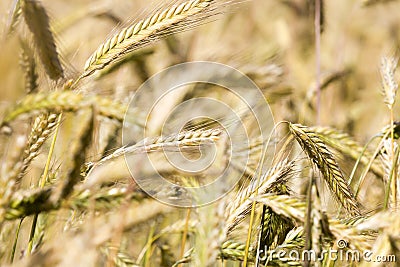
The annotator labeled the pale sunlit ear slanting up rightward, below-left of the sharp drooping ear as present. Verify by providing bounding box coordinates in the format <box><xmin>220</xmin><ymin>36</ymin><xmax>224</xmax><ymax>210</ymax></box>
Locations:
<box><xmin>226</xmin><ymin>160</ymin><xmax>294</xmax><ymax>235</ymax></box>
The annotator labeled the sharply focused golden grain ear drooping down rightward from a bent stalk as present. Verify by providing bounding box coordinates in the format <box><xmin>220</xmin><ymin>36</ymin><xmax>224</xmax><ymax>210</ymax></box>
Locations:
<box><xmin>289</xmin><ymin>123</ymin><xmax>360</xmax><ymax>218</ymax></box>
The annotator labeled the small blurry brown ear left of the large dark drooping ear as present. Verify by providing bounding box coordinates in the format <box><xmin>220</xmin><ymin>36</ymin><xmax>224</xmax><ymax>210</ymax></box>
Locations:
<box><xmin>20</xmin><ymin>40</ymin><xmax>38</xmax><ymax>94</ymax></box>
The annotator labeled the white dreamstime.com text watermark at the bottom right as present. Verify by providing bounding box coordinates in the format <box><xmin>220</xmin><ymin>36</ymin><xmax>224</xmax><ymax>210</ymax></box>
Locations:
<box><xmin>259</xmin><ymin>239</ymin><xmax>396</xmax><ymax>263</ymax></box>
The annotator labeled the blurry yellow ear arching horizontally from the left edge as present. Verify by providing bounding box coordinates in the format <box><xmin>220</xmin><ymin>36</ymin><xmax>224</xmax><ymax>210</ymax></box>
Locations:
<box><xmin>2</xmin><ymin>91</ymin><xmax>127</xmax><ymax>125</ymax></box>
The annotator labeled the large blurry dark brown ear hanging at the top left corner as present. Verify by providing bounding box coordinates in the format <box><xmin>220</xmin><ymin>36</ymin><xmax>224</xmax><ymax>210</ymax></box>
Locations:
<box><xmin>21</xmin><ymin>0</ymin><xmax>64</xmax><ymax>80</ymax></box>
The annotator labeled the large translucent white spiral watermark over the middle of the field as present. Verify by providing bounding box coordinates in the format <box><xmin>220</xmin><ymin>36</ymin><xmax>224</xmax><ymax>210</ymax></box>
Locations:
<box><xmin>123</xmin><ymin>62</ymin><xmax>274</xmax><ymax>207</ymax></box>
